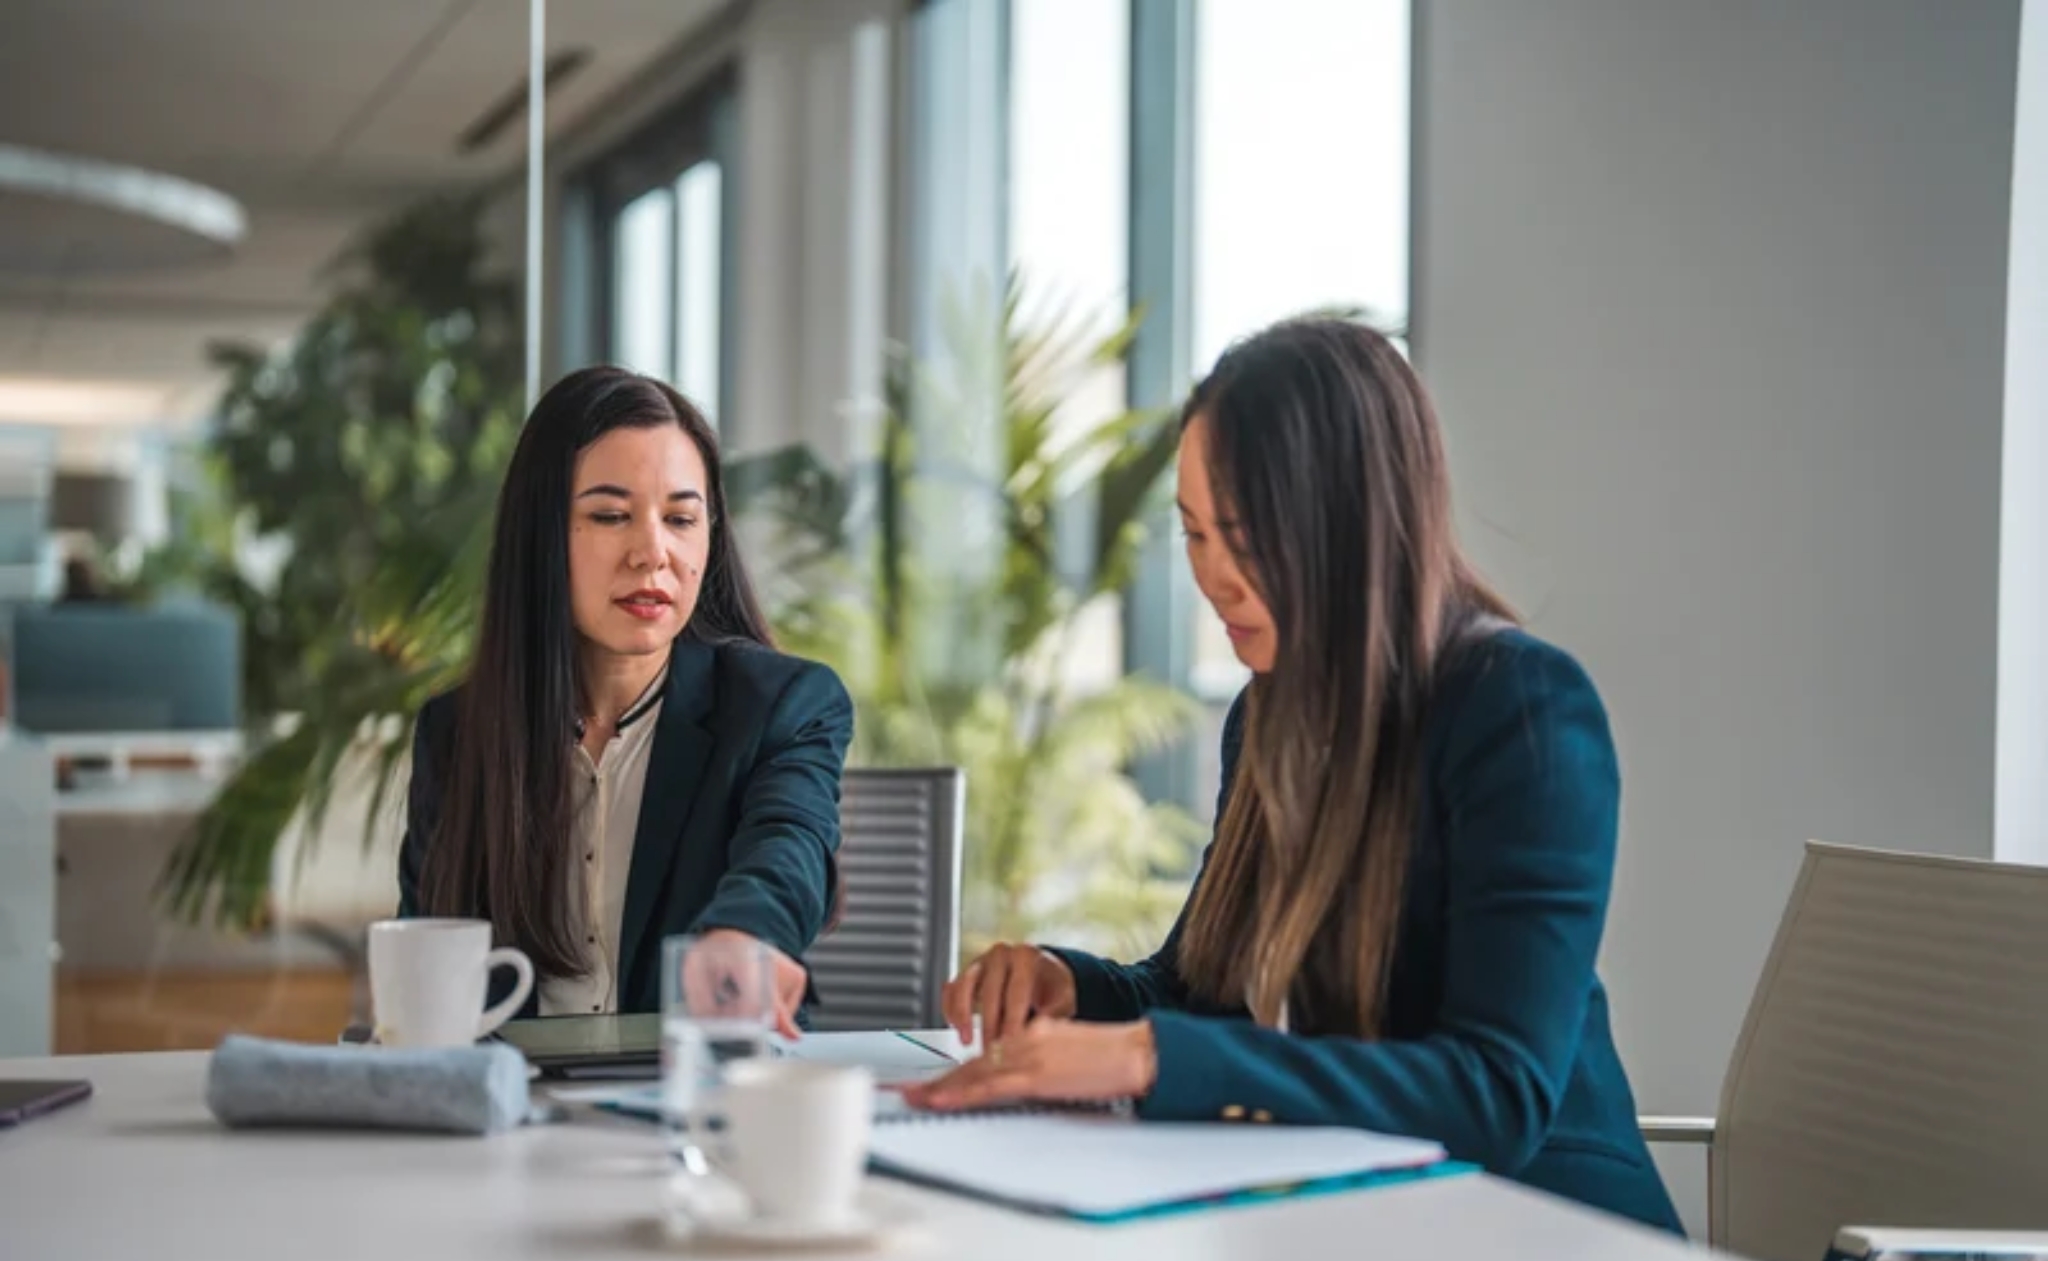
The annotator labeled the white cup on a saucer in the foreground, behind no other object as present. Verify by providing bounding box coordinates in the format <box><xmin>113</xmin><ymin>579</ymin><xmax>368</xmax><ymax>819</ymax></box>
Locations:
<box><xmin>698</xmin><ymin>1058</ymin><xmax>874</xmax><ymax>1228</ymax></box>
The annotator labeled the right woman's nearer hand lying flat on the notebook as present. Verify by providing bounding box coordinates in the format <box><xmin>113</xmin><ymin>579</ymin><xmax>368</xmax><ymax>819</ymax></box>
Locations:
<box><xmin>903</xmin><ymin>1019</ymin><xmax>1159</xmax><ymax>1112</ymax></box>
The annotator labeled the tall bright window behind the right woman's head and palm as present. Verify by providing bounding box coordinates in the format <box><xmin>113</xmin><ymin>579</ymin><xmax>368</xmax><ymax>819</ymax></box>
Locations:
<box><xmin>909</xmin><ymin>0</ymin><xmax>1411</xmax><ymax>813</ymax></box>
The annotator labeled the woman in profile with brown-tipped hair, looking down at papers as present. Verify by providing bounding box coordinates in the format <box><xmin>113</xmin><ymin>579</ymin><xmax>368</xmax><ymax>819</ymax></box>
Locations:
<box><xmin>911</xmin><ymin>319</ymin><xmax>1679</xmax><ymax>1230</ymax></box>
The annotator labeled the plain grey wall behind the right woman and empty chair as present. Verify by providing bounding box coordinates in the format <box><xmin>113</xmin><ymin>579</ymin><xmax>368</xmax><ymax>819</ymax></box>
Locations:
<box><xmin>1413</xmin><ymin>0</ymin><xmax>2019</xmax><ymax>1222</ymax></box>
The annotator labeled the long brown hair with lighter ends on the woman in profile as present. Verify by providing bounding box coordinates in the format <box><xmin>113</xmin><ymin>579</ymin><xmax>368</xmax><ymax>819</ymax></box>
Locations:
<box><xmin>1180</xmin><ymin>319</ymin><xmax>1513</xmax><ymax>1038</ymax></box>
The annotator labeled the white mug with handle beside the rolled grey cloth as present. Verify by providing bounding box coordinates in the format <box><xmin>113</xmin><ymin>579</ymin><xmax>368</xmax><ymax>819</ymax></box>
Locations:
<box><xmin>371</xmin><ymin>919</ymin><xmax>532</xmax><ymax>1046</ymax></box>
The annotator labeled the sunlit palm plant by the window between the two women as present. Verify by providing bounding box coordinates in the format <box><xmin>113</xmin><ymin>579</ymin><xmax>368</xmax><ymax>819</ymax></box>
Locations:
<box><xmin>735</xmin><ymin>278</ymin><xmax>1202</xmax><ymax>952</ymax></box>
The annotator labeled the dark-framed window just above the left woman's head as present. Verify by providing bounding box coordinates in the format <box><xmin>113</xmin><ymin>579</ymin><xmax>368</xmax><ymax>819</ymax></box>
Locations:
<box><xmin>580</xmin><ymin>80</ymin><xmax>735</xmax><ymax>420</ymax></box>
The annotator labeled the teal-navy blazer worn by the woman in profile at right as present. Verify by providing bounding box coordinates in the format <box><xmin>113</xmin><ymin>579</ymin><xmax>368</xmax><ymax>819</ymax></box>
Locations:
<box><xmin>1057</xmin><ymin>631</ymin><xmax>1681</xmax><ymax>1232</ymax></box>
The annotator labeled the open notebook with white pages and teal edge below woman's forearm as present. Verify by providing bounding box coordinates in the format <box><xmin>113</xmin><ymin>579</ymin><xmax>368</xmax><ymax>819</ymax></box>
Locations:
<box><xmin>868</xmin><ymin>1112</ymin><xmax>1475</xmax><ymax>1222</ymax></box>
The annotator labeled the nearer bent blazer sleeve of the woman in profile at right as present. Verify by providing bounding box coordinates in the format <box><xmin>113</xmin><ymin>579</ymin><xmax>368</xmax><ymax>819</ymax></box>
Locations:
<box><xmin>1139</xmin><ymin>645</ymin><xmax>1620</xmax><ymax>1173</ymax></box>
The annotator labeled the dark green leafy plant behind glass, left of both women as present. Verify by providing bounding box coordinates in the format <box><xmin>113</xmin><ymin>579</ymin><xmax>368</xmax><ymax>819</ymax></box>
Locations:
<box><xmin>149</xmin><ymin>199</ymin><xmax>522</xmax><ymax>929</ymax></box>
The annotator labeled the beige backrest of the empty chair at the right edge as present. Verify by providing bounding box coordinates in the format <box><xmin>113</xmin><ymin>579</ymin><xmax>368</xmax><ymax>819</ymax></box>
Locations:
<box><xmin>1708</xmin><ymin>843</ymin><xmax>2048</xmax><ymax>1261</ymax></box>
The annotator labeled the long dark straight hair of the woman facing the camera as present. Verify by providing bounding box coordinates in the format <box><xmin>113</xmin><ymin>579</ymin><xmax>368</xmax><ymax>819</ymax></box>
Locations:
<box><xmin>420</xmin><ymin>366</ymin><xmax>774</xmax><ymax>976</ymax></box>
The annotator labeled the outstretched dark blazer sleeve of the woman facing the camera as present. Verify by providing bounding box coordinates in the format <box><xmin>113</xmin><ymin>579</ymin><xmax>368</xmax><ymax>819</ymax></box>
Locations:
<box><xmin>690</xmin><ymin>661</ymin><xmax>854</xmax><ymax>958</ymax></box>
